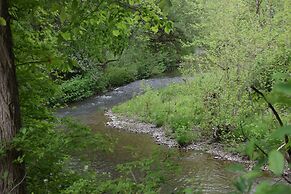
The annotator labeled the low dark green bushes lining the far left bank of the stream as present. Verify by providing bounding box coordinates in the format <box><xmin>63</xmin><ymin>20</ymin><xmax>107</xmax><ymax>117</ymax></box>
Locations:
<box><xmin>53</xmin><ymin>35</ymin><xmax>177</xmax><ymax>103</ymax></box>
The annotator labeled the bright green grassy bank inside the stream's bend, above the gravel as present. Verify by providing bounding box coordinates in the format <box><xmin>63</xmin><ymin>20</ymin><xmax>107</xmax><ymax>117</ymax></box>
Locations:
<box><xmin>113</xmin><ymin>71</ymin><xmax>291</xmax><ymax>153</ymax></box>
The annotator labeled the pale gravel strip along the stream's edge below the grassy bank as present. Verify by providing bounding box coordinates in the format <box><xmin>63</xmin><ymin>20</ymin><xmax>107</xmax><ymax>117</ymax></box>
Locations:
<box><xmin>105</xmin><ymin>110</ymin><xmax>254</xmax><ymax>166</ymax></box>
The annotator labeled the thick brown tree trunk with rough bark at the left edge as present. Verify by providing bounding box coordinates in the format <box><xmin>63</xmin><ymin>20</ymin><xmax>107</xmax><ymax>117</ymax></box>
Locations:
<box><xmin>0</xmin><ymin>0</ymin><xmax>25</xmax><ymax>194</ymax></box>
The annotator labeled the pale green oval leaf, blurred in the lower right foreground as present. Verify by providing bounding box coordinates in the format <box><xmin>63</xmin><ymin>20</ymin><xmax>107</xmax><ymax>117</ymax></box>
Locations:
<box><xmin>269</xmin><ymin>150</ymin><xmax>284</xmax><ymax>175</ymax></box>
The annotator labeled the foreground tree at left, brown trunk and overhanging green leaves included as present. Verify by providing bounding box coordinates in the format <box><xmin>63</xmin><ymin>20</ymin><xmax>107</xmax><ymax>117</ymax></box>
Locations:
<box><xmin>0</xmin><ymin>0</ymin><xmax>173</xmax><ymax>193</ymax></box>
